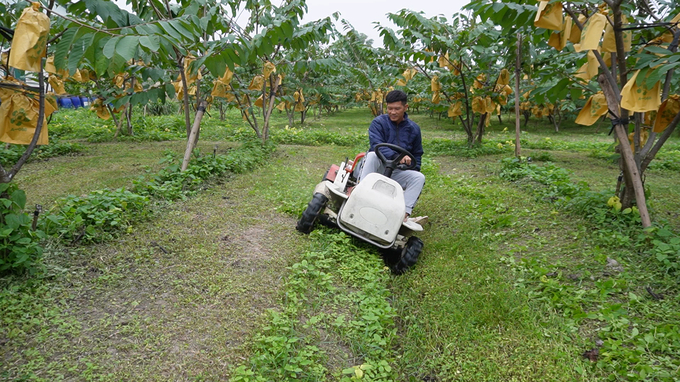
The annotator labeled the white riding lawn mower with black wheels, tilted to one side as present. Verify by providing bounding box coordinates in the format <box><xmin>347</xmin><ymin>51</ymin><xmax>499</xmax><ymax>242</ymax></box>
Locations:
<box><xmin>296</xmin><ymin>143</ymin><xmax>423</xmax><ymax>274</ymax></box>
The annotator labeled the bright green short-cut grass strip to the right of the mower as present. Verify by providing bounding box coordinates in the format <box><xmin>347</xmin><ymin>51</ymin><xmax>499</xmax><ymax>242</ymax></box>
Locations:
<box><xmin>391</xmin><ymin>160</ymin><xmax>580</xmax><ymax>381</ymax></box>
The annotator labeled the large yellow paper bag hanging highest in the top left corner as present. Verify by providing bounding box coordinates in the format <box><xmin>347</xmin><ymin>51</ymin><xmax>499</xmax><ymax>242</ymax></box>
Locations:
<box><xmin>9</xmin><ymin>2</ymin><xmax>50</xmax><ymax>72</ymax></box>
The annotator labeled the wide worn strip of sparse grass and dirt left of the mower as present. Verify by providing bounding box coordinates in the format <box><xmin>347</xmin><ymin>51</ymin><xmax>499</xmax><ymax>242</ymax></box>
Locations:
<box><xmin>0</xmin><ymin>157</ymin><xmax>299</xmax><ymax>381</ymax></box>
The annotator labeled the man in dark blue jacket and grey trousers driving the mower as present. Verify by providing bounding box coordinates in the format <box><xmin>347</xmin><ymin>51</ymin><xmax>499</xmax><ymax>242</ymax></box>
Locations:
<box><xmin>359</xmin><ymin>90</ymin><xmax>425</xmax><ymax>223</ymax></box>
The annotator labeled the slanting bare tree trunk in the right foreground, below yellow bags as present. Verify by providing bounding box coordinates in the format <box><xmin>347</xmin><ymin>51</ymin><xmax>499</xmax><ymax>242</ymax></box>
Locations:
<box><xmin>597</xmin><ymin>74</ymin><xmax>652</xmax><ymax>228</ymax></box>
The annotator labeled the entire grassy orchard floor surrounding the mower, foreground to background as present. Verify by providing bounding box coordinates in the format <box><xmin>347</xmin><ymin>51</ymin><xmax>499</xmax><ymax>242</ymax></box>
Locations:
<box><xmin>0</xmin><ymin>109</ymin><xmax>680</xmax><ymax>381</ymax></box>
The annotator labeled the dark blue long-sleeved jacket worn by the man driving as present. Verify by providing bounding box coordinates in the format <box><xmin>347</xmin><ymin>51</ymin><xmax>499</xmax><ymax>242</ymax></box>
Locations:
<box><xmin>368</xmin><ymin>113</ymin><xmax>423</xmax><ymax>171</ymax></box>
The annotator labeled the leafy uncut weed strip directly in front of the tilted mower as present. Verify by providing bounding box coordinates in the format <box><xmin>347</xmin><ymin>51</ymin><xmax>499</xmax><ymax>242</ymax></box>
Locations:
<box><xmin>231</xmin><ymin>230</ymin><xmax>396</xmax><ymax>382</ymax></box>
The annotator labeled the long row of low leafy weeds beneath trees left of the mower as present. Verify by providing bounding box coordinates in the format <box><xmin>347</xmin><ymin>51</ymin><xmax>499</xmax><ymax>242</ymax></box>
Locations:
<box><xmin>43</xmin><ymin>142</ymin><xmax>273</xmax><ymax>244</ymax></box>
